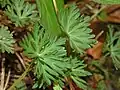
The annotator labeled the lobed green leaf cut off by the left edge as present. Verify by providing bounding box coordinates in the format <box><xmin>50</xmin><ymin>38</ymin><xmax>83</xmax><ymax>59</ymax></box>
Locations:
<box><xmin>0</xmin><ymin>26</ymin><xmax>15</xmax><ymax>53</ymax></box>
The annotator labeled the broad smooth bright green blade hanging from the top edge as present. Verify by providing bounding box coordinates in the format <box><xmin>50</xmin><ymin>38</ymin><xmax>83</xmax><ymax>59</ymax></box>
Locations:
<box><xmin>36</xmin><ymin>0</ymin><xmax>61</xmax><ymax>36</ymax></box>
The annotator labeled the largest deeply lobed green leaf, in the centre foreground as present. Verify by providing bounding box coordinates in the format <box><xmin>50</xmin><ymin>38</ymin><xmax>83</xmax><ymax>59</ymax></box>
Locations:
<box><xmin>20</xmin><ymin>24</ymin><xmax>68</xmax><ymax>88</ymax></box>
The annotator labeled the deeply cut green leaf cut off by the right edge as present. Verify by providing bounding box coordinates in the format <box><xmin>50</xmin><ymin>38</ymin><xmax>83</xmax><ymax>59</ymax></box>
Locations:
<box><xmin>103</xmin><ymin>25</ymin><xmax>120</xmax><ymax>69</ymax></box>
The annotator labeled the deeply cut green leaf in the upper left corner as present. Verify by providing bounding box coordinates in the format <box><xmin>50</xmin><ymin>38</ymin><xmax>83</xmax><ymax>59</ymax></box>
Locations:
<box><xmin>5</xmin><ymin>0</ymin><xmax>39</xmax><ymax>26</ymax></box>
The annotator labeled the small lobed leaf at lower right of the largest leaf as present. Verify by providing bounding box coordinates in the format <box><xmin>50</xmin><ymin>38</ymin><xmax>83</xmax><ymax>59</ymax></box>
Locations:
<box><xmin>66</xmin><ymin>58</ymin><xmax>91</xmax><ymax>90</ymax></box>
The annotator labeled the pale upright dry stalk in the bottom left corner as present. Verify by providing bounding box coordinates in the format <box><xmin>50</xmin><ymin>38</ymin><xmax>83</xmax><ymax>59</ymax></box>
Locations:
<box><xmin>0</xmin><ymin>58</ymin><xmax>5</xmax><ymax>90</ymax></box>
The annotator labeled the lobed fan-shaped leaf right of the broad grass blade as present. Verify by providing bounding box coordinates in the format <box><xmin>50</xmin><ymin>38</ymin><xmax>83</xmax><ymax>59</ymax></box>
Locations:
<box><xmin>59</xmin><ymin>4</ymin><xmax>95</xmax><ymax>53</ymax></box>
